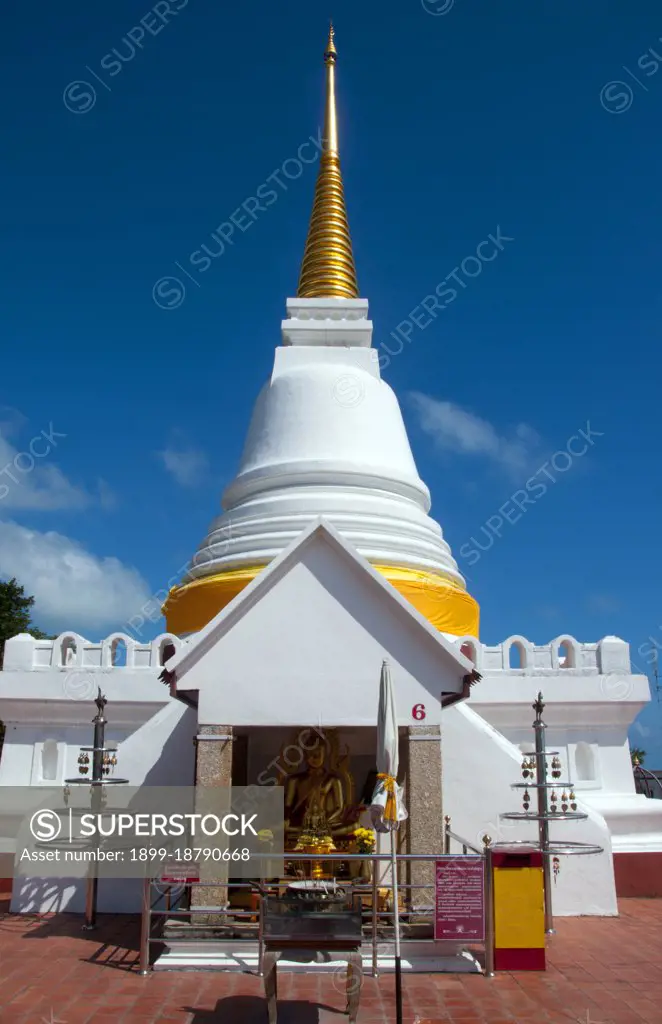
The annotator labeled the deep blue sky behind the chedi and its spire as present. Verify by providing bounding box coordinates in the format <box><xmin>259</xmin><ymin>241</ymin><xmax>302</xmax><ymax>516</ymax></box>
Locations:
<box><xmin>0</xmin><ymin>0</ymin><xmax>662</xmax><ymax>767</ymax></box>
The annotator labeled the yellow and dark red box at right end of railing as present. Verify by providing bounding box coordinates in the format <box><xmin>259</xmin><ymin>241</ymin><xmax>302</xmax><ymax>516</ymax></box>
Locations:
<box><xmin>492</xmin><ymin>846</ymin><xmax>545</xmax><ymax>971</ymax></box>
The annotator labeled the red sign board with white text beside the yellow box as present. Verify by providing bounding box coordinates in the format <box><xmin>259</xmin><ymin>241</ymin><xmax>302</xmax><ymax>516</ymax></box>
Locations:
<box><xmin>435</xmin><ymin>856</ymin><xmax>485</xmax><ymax>942</ymax></box>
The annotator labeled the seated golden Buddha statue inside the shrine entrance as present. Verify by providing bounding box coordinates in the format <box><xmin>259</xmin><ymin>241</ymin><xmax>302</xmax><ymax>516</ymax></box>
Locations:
<box><xmin>284</xmin><ymin>733</ymin><xmax>358</xmax><ymax>845</ymax></box>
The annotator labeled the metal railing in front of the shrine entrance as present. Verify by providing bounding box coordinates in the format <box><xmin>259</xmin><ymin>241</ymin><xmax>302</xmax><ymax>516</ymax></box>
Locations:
<box><xmin>139</xmin><ymin>843</ymin><xmax>494</xmax><ymax>977</ymax></box>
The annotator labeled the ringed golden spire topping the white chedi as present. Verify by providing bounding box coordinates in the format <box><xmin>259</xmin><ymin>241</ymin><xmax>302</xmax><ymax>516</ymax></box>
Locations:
<box><xmin>297</xmin><ymin>26</ymin><xmax>359</xmax><ymax>299</ymax></box>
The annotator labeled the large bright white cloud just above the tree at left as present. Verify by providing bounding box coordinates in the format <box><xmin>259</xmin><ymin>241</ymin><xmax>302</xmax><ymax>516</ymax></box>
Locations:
<box><xmin>0</xmin><ymin>522</ymin><xmax>151</xmax><ymax>635</ymax></box>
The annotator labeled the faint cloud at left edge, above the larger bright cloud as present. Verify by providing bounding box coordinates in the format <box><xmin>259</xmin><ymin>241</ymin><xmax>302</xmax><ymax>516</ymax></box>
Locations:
<box><xmin>0</xmin><ymin>419</ymin><xmax>101</xmax><ymax>513</ymax></box>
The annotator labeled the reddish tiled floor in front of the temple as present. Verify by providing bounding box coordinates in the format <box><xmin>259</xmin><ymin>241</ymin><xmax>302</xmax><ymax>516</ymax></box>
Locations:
<box><xmin>0</xmin><ymin>900</ymin><xmax>662</xmax><ymax>1024</ymax></box>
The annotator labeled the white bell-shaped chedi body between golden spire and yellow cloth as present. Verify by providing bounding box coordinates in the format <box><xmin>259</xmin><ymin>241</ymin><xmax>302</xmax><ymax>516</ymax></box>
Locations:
<box><xmin>182</xmin><ymin>299</ymin><xmax>464</xmax><ymax>587</ymax></box>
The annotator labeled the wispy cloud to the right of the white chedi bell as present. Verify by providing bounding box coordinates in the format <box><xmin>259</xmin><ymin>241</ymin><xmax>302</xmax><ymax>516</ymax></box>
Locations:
<box><xmin>409</xmin><ymin>391</ymin><xmax>540</xmax><ymax>472</ymax></box>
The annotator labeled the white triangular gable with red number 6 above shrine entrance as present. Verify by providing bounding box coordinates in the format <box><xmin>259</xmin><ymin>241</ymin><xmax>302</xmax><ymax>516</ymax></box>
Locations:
<box><xmin>166</xmin><ymin>519</ymin><xmax>473</xmax><ymax>725</ymax></box>
